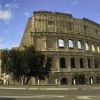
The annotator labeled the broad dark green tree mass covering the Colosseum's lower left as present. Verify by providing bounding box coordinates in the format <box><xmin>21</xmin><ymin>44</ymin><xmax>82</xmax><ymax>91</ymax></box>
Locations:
<box><xmin>1</xmin><ymin>46</ymin><xmax>52</xmax><ymax>85</ymax></box>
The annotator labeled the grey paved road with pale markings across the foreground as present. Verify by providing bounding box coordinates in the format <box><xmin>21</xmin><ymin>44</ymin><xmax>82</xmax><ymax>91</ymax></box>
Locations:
<box><xmin>0</xmin><ymin>87</ymin><xmax>100</xmax><ymax>100</ymax></box>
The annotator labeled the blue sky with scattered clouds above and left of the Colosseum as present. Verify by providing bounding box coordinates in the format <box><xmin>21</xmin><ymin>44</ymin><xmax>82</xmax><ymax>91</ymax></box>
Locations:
<box><xmin>0</xmin><ymin>0</ymin><xmax>100</xmax><ymax>48</ymax></box>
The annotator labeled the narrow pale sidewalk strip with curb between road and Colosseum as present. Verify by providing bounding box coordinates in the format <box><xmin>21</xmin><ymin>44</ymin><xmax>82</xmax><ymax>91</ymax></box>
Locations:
<box><xmin>0</xmin><ymin>85</ymin><xmax>100</xmax><ymax>90</ymax></box>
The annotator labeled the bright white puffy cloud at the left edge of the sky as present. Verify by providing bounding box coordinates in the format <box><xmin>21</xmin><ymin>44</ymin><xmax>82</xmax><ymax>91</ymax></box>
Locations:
<box><xmin>0</xmin><ymin>10</ymin><xmax>12</xmax><ymax>21</ymax></box>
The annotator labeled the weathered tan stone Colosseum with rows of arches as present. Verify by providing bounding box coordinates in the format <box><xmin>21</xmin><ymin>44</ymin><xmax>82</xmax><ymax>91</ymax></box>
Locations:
<box><xmin>20</xmin><ymin>11</ymin><xmax>100</xmax><ymax>85</ymax></box>
